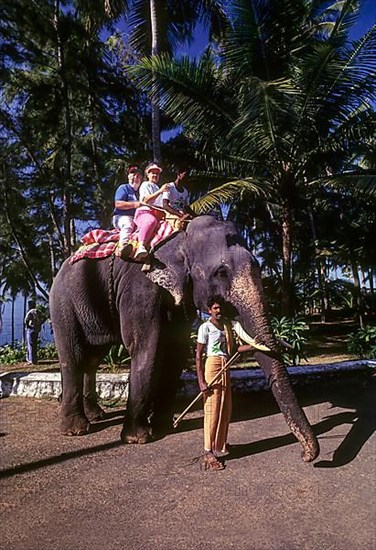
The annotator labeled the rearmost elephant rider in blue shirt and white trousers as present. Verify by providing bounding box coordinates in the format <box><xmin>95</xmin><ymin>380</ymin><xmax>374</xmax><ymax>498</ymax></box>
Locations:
<box><xmin>112</xmin><ymin>166</ymin><xmax>142</xmax><ymax>255</ymax></box>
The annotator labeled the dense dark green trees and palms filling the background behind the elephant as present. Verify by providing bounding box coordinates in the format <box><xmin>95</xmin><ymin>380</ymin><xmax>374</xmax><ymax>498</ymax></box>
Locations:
<box><xmin>0</xmin><ymin>0</ymin><xmax>376</xmax><ymax>324</ymax></box>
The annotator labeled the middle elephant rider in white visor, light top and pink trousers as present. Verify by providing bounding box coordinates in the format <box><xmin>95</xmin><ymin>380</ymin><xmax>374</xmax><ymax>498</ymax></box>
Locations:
<box><xmin>134</xmin><ymin>162</ymin><xmax>168</xmax><ymax>261</ymax></box>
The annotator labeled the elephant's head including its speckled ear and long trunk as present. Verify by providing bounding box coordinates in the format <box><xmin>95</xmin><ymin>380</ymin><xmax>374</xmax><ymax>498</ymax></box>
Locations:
<box><xmin>148</xmin><ymin>216</ymin><xmax>319</xmax><ymax>462</ymax></box>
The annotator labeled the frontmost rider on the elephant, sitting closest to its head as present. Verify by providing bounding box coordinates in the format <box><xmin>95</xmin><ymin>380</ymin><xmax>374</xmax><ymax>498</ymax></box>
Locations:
<box><xmin>162</xmin><ymin>168</ymin><xmax>195</xmax><ymax>229</ymax></box>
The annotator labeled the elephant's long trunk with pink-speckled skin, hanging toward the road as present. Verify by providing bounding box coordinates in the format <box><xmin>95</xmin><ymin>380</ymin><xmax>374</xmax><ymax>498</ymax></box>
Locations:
<box><xmin>230</xmin><ymin>264</ymin><xmax>319</xmax><ymax>462</ymax></box>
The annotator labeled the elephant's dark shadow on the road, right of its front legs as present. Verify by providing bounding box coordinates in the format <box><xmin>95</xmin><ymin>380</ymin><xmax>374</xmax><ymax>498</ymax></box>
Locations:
<box><xmin>179</xmin><ymin>372</ymin><xmax>376</xmax><ymax>468</ymax></box>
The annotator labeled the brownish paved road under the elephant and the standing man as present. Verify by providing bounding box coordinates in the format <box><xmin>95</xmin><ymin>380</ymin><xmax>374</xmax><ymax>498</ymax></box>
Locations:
<box><xmin>0</xmin><ymin>375</ymin><xmax>376</xmax><ymax>550</ymax></box>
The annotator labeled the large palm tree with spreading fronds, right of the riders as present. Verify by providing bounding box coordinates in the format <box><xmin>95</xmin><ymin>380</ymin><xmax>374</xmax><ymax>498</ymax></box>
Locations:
<box><xmin>131</xmin><ymin>0</ymin><xmax>376</xmax><ymax>314</ymax></box>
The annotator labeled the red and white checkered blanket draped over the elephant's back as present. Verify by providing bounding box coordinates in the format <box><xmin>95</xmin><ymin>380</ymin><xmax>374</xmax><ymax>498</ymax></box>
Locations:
<box><xmin>69</xmin><ymin>221</ymin><xmax>173</xmax><ymax>264</ymax></box>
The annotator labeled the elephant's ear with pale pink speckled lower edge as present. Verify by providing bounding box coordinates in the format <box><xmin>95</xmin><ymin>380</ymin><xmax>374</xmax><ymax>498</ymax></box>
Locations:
<box><xmin>147</xmin><ymin>233</ymin><xmax>189</xmax><ymax>305</ymax></box>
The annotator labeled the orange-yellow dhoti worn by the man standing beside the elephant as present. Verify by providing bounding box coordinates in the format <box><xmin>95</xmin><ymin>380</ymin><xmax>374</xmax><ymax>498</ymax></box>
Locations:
<box><xmin>204</xmin><ymin>356</ymin><xmax>232</xmax><ymax>452</ymax></box>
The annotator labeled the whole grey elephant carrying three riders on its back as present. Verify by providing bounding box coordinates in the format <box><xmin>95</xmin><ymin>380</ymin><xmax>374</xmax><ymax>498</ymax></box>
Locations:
<box><xmin>50</xmin><ymin>215</ymin><xmax>319</xmax><ymax>462</ymax></box>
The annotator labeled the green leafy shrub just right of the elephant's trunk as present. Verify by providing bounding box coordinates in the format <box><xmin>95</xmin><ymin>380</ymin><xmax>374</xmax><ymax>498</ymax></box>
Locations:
<box><xmin>271</xmin><ymin>317</ymin><xmax>309</xmax><ymax>366</ymax></box>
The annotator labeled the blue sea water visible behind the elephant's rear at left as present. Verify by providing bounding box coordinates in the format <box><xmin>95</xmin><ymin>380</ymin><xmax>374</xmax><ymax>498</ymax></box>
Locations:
<box><xmin>0</xmin><ymin>295</ymin><xmax>53</xmax><ymax>346</ymax></box>
